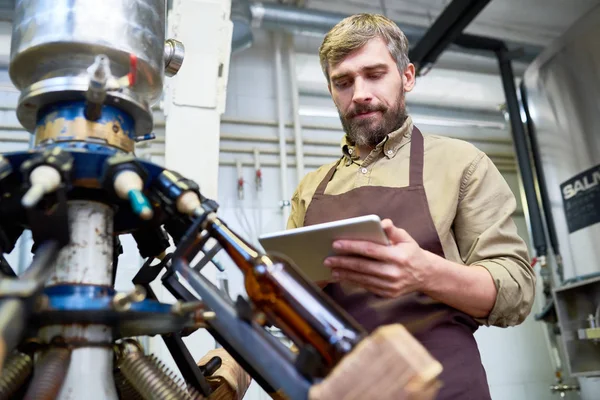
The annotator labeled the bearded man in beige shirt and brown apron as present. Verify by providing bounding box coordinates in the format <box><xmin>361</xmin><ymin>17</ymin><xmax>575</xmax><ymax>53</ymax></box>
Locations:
<box><xmin>288</xmin><ymin>14</ymin><xmax>535</xmax><ymax>400</ymax></box>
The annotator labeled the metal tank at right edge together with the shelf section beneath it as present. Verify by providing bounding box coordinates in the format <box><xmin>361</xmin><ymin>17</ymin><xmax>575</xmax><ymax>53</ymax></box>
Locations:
<box><xmin>523</xmin><ymin>6</ymin><xmax>600</xmax><ymax>399</ymax></box>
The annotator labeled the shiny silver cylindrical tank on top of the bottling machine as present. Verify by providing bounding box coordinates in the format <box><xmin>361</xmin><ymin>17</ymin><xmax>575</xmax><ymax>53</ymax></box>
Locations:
<box><xmin>9</xmin><ymin>0</ymin><xmax>166</xmax><ymax>133</ymax></box>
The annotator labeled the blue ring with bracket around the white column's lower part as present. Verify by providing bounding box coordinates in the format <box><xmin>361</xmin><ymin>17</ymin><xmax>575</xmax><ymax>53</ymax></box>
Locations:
<box><xmin>39</xmin><ymin>285</ymin><xmax>195</xmax><ymax>337</ymax></box>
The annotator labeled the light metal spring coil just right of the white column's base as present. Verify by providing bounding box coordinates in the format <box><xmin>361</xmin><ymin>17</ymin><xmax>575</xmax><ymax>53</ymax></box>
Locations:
<box><xmin>120</xmin><ymin>354</ymin><xmax>204</xmax><ymax>400</ymax></box>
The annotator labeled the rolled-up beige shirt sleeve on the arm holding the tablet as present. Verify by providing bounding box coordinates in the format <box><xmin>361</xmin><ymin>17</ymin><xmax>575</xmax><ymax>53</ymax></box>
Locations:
<box><xmin>454</xmin><ymin>153</ymin><xmax>536</xmax><ymax>327</ymax></box>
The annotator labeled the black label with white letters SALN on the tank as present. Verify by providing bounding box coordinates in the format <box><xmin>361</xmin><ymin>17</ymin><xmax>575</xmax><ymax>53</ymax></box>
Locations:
<box><xmin>560</xmin><ymin>165</ymin><xmax>600</xmax><ymax>233</ymax></box>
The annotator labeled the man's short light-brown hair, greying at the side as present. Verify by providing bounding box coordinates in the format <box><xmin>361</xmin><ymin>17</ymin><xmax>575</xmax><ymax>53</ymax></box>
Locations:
<box><xmin>319</xmin><ymin>14</ymin><xmax>409</xmax><ymax>82</ymax></box>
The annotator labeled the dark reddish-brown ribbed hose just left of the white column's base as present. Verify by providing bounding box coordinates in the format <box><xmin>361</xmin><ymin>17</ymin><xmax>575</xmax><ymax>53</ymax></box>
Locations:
<box><xmin>24</xmin><ymin>347</ymin><xmax>71</xmax><ymax>400</ymax></box>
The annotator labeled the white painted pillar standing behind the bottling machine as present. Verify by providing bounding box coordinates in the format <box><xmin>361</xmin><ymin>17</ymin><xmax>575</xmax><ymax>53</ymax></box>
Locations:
<box><xmin>157</xmin><ymin>0</ymin><xmax>233</xmax><ymax>370</ymax></box>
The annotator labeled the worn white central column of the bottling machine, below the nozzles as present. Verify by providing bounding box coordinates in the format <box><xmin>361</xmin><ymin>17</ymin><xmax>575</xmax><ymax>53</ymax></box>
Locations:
<box><xmin>40</xmin><ymin>201</ymin><xmax>118</xmax><ymax>400</ymax></box>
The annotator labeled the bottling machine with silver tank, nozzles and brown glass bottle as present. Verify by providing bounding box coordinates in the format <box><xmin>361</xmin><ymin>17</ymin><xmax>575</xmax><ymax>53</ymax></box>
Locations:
<box><xmin>0</xmin><ymin>0</ymin><xmax>412</xmax><ymax>400</ymax></box>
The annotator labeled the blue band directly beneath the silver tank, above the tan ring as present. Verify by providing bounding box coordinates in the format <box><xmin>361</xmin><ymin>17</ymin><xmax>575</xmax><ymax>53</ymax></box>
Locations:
<box><xmin>37</xmin><ymin>101</ymin><xmax>136</xmax><ymax>140</ymax></box>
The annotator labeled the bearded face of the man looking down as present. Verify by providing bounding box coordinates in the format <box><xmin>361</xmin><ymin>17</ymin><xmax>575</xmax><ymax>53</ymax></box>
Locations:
<box><xmin>329</xmin><ymin>38</ymin><xmax>414</xmax><ymax>147</ymax></box>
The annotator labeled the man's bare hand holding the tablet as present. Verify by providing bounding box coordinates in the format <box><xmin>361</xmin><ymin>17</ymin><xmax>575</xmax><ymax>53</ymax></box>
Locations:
<box><xmin>325</xmin><ymin>219</ymin><xmax>433</xmax><ymax>298</ymax></box>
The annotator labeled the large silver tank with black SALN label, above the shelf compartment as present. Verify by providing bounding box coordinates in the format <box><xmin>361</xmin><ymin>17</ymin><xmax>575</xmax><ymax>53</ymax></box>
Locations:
<box><xmin>524</xmin><ymin>6</ymin><xmax>600</xmax><ymax>400</ymax></box>
